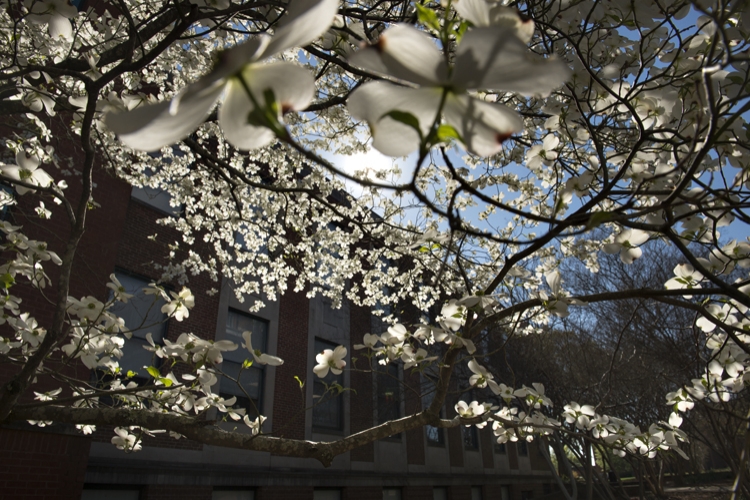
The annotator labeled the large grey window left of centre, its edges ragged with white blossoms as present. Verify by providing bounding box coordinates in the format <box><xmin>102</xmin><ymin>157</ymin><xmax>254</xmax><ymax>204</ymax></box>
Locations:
<box><xmin>110</xmin><ymin>271</ymin><xmax>167</xmax><ymax>380</ymax></box>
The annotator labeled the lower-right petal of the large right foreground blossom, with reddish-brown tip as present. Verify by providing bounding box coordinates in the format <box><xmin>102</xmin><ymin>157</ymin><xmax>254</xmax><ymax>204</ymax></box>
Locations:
<box><xmin>443</xmin><ymin>94</ymin><xmax>523</xmax><ymax>156</ymax></box>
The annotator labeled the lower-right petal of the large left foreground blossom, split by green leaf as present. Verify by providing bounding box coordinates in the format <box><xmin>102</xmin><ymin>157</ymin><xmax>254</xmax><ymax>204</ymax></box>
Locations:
<box><xmin>219</xmin><ymin>62</ymin><xmax>315</xmax><ymax>149</ymax></box>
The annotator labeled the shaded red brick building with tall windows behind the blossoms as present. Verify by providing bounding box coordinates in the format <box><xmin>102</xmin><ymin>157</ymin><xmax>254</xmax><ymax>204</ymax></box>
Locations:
<box><xmin>0</xmin><ymin>154</ymin><xmax>551</xmax><ymax>500</ymax></box>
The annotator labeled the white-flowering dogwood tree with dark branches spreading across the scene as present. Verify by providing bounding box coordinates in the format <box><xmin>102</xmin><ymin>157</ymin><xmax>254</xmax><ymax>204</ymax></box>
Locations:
<box><xmin>0</xmin><ymin>0</ymin><xmax>750</xmax><ymax>492</ymax></box>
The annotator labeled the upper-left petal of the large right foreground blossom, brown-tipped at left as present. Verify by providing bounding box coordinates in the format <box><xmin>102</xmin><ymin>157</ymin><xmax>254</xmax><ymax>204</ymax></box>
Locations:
<box><xmin>349</xmin><ymin>24</ymin><xmax>448</xmax><ymax>85</ymax></box>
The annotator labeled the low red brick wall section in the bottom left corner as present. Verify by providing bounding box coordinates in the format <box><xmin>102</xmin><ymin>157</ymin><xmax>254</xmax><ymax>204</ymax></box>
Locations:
<box><xmin>0</xmin><ymin>429</ymin><xmax>91</xmax><ymax>500</ymax></box>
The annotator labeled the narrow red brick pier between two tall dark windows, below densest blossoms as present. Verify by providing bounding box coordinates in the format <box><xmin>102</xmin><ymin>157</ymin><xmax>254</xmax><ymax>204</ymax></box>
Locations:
<box><xmin>273</xmin><ymin>290</ymin><xmax>312</xmax><ymax>439</ymax></box>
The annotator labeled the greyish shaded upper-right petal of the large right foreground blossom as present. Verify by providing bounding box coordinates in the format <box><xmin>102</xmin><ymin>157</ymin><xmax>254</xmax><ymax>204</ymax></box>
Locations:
<box><xmin>453</xmin><ymin>27</ymin><xmax>570</xmax><ymax>95</ymax></box>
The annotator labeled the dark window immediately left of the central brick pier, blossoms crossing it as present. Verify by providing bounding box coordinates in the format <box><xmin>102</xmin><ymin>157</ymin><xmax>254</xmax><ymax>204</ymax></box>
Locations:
<box><xmin>219</xmin><ymin>309</ymin><xmax>268</xmax><ymax>418</ymax></box>
